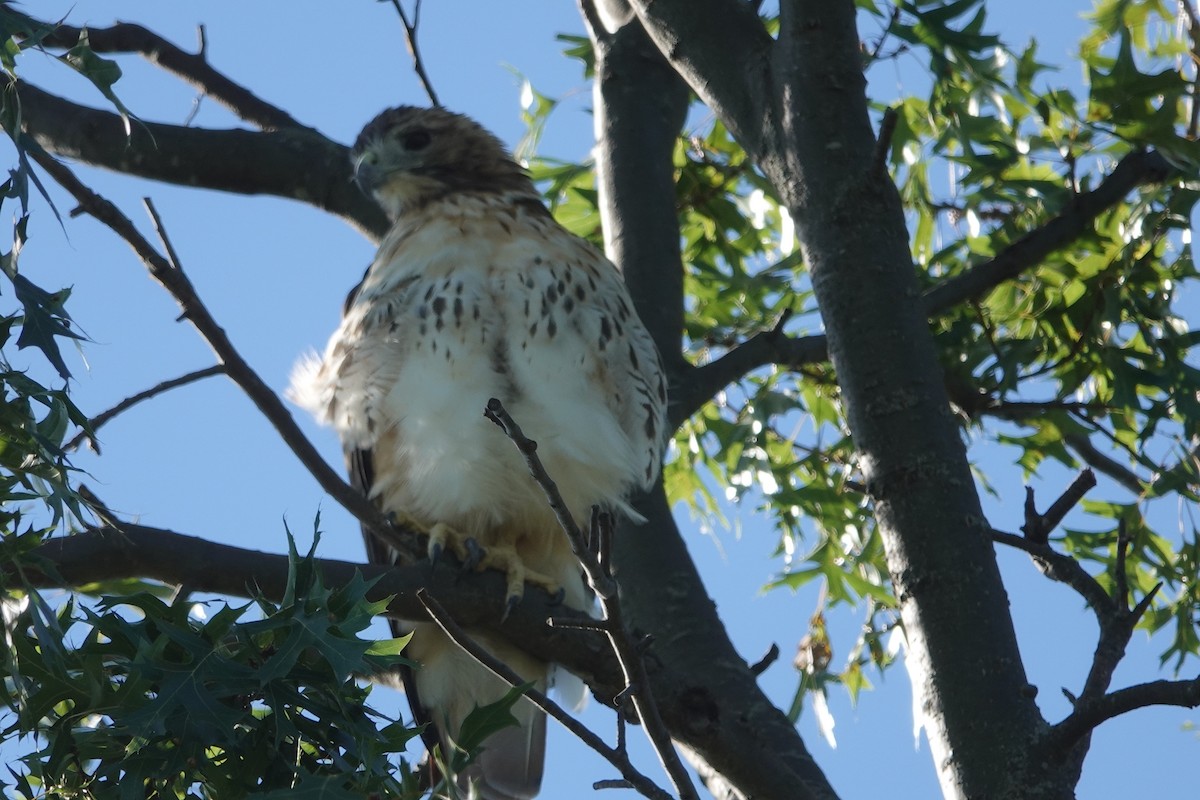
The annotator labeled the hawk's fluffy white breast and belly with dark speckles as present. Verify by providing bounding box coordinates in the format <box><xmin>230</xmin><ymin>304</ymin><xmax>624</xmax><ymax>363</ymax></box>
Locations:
<box><xmin>293</xmin><ymin>200</ymin><xmax>664</xmax><ymax>542</ymax></box>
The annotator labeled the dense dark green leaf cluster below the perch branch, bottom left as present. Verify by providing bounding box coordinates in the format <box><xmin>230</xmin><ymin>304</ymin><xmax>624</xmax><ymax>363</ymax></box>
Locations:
<box><xmin>0</xmin><ymin>539</ymin><xmax>420</xmax><ymax>799</ymax></box>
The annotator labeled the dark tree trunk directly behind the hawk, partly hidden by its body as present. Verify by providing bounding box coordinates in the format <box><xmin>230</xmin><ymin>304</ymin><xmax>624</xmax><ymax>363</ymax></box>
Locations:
<box><xmin>593</xmin><ymin>2</ymin><xmax>835</xmax><ymax>800</ymax></box>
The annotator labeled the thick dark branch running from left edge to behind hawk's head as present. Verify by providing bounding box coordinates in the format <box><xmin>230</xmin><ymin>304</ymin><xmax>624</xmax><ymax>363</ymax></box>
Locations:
<box><xmin>0</xmin><ymin>78</ymin><xmax>388</xmax><ymax>241</ymax></box>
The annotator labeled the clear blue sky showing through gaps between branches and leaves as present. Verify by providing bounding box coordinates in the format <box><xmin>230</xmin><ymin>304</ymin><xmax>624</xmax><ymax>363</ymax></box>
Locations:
<box><xmin>10</xmin><ymin>0</ymin><xmax>1200</xmax><ymax>798</ymax></box>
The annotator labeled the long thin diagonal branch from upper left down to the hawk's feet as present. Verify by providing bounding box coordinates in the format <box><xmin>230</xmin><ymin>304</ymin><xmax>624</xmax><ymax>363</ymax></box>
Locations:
<box><xmin>30</xmin><ymin>149</ymin><xmax>424</xmax><ymax>561</ymax></box>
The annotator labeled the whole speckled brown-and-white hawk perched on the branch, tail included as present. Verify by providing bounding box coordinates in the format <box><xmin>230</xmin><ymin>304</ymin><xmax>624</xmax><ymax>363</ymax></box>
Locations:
<box><xmin>292</xmin><ymin>106</ymin><xmax>666</xmax><ymax>800</ymax></box>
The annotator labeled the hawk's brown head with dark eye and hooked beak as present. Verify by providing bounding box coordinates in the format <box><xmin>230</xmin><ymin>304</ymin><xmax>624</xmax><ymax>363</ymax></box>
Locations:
<box><xmin>350</xmin><ymin>106</ymin><xmax>535</xmax><ymax>219</ymax></box>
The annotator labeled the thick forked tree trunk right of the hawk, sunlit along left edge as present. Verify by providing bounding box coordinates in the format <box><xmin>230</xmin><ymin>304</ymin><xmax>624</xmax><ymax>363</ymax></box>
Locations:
<box><xmin>632</xmin><ymin>0</ymin><xmax>1069</xmax><ymax>800</ymax></box>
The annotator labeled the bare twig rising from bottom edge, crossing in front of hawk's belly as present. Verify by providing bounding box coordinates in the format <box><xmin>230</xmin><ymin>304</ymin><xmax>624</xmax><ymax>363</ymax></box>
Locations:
<box><xmin>485</xmin><ymin>397</ymin><xmax>700</xmax><ymax>800</ymax></box>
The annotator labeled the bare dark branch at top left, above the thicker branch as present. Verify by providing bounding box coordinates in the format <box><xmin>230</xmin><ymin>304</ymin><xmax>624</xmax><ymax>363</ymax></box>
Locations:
<box><xmin>42</xmin><ymin>23</ymin><xmax>305</xmax><ymax>131</ymax></box>
